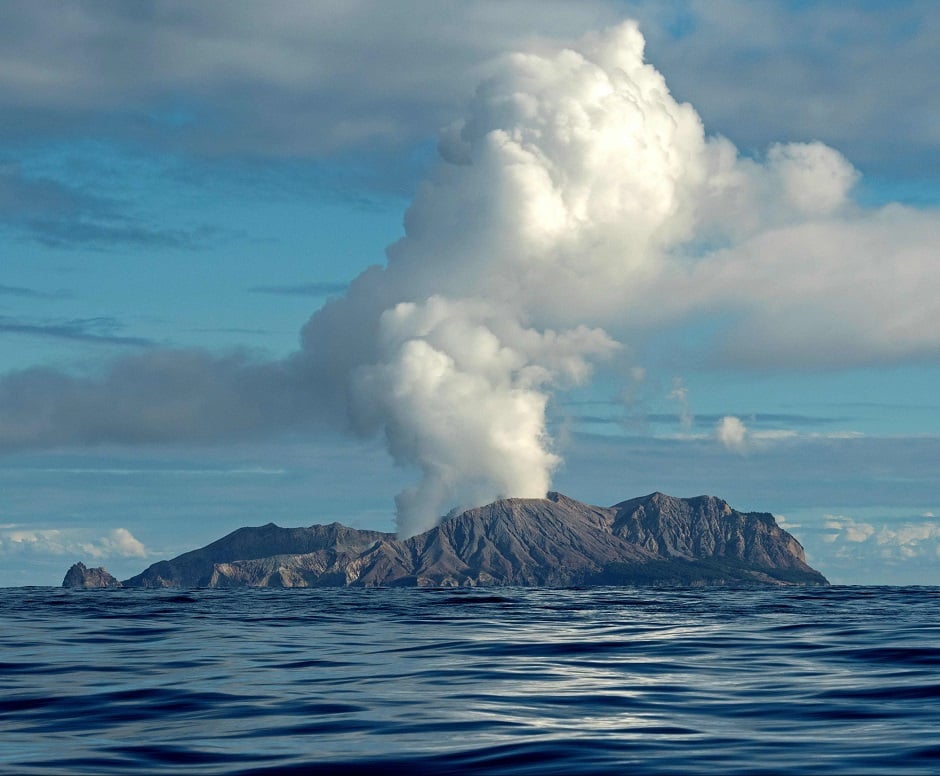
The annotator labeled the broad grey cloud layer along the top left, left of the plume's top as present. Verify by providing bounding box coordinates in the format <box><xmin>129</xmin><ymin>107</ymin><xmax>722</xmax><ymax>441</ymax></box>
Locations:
<box><xmin>0</xmin><ymin>0</ymin><xmax>615</xmax><ymax>157</ymax></box>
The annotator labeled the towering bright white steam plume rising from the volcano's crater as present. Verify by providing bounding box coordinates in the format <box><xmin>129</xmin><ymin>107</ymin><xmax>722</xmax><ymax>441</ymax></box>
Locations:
<box><xmin>305</xmin><ymin>23</ymin><xmax>706</xmax><ymax>535</ymax></box>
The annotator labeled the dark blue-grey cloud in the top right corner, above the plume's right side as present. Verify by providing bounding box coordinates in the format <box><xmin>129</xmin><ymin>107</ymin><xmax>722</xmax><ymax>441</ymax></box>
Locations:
<box><xmin>644</xmin><ymin>0</ymin><xmax>940</xmax><ymax>177</ymax></box>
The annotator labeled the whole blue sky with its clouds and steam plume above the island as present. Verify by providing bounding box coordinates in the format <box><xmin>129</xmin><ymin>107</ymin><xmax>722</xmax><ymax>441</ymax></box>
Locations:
<box><xmin>0</xmin><ymin>0</ymin><xmax>940</xmax><ymax>586</ymax></box>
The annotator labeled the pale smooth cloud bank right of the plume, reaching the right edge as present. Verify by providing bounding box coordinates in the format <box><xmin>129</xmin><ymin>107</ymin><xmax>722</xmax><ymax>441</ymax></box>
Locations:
<box><xmin>664</xmin><ymin>205</ymin><xmax>940</xmax><ymax>369</ymax></box>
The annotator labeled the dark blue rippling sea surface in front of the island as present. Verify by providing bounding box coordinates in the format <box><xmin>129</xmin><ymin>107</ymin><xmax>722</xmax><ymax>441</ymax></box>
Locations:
<box><xmin>0</xmin><ymin>587</ymin><xmax>940</xmax><ymax>776</ymax></box>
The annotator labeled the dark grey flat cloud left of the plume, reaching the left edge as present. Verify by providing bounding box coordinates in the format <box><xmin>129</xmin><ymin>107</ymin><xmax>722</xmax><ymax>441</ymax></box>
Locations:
<box><xmin>0</xmin><ymin>350</ymin><xmax>324</xmax><ymax>451</ymax></box>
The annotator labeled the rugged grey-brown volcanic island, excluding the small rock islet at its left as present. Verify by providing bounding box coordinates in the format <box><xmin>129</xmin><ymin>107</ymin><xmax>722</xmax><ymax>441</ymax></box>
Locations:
<box><xmin>86</xmin><ymin>493</ymin><xmax>828</xmax><ymax>587</ymax></box>
